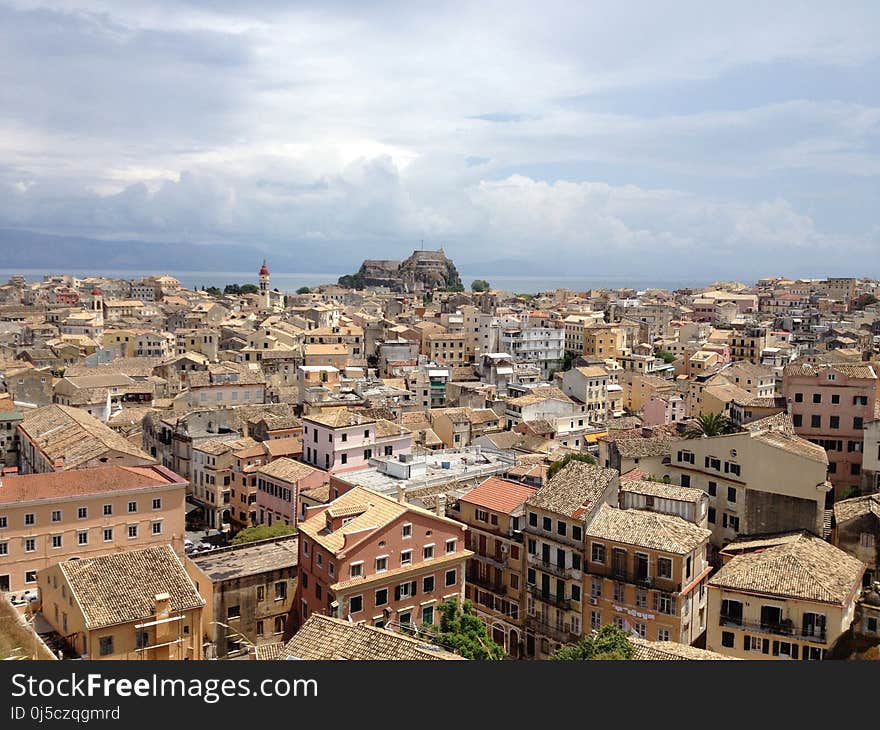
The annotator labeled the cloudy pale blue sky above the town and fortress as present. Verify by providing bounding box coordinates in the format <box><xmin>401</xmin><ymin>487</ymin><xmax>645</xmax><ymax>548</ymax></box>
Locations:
<box><xmin>0</xmin><ymin>0</ymin><xmax>880</xmax><ymax>276</ymax></box>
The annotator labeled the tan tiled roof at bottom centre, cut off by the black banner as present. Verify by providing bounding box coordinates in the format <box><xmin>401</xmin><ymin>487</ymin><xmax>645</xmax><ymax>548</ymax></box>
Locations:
<box><xmin>279</xmin><ymin>614</ymin><xmax>462</xmax><ymax>661</ymax></box>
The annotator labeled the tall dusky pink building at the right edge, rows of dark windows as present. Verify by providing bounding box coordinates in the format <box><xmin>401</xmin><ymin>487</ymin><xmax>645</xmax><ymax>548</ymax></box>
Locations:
<box><xmin>782</xmin><ymin>363</ymin><xmax>878</xmax><ymax>496</ymax></box>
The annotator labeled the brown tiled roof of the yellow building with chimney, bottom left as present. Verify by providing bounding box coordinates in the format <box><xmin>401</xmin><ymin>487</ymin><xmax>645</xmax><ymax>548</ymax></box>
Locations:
<box><xmin>59</xmin><ymin>545</ymin><xmax>205</xmax><ymax>629</ymax></box>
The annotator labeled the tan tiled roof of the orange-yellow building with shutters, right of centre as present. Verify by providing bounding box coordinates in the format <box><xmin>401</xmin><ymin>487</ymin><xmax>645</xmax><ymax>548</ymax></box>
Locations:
<box><xmin>586</xmin><ymin>504</ymin><xmax>712</xmax><ymax>555</ymax></box>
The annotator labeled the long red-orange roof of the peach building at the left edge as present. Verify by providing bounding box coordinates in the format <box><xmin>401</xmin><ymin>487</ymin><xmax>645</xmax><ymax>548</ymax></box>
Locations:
<box><xmin>0</xmin><ymin>466</ymin><xmax>186</xmax><ymax>504</ymax></box>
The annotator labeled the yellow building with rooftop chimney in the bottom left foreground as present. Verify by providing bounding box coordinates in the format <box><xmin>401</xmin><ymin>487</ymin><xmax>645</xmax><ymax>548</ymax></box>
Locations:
<box><xmin>38</xmin><ymin>545</ymin><xmax>205</xmax><ymax>659</ymax></box>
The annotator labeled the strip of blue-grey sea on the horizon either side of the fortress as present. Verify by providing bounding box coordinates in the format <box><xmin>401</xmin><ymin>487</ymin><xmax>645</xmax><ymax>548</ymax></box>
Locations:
<box><xmin>0</xmin><ymin>269</ymin><xmax>711</xmax><ymax>294</ymax></box>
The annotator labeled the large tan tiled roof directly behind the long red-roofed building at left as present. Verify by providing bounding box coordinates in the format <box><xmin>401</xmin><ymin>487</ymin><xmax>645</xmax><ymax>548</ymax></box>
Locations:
<box><xmin>19</xmin><ymin>405</ymin><xmax>155</xmax><ymax>469</ymax></box>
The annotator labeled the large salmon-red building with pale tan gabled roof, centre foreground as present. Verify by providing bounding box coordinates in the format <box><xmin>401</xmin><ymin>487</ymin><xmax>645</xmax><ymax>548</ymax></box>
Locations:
<box><xmin>293</xmin><ymin>487</ymin><xmax>473</xmax><ymax>629</ymax></box>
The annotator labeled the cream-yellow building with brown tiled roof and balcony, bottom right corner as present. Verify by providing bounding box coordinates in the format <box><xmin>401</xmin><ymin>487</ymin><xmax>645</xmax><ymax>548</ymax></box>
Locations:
<box><xmin>706</xmin><ymin>532</ymin><xmax>865</xmax><ymax>659</ymax></box>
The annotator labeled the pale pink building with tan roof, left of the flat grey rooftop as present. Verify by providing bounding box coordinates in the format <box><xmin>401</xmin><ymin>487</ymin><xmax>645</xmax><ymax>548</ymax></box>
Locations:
<box><xmin>303</xmin><ymin>408</ymin><xmax>412</xmax><ymax>472</ymax></box>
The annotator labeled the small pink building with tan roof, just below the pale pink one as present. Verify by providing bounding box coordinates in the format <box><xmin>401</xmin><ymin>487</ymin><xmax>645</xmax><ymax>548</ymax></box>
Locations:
<box><xmin>256</xmin><ymin>458</ymin><xmax>330</xmax><ymax>526</ymax></box>
